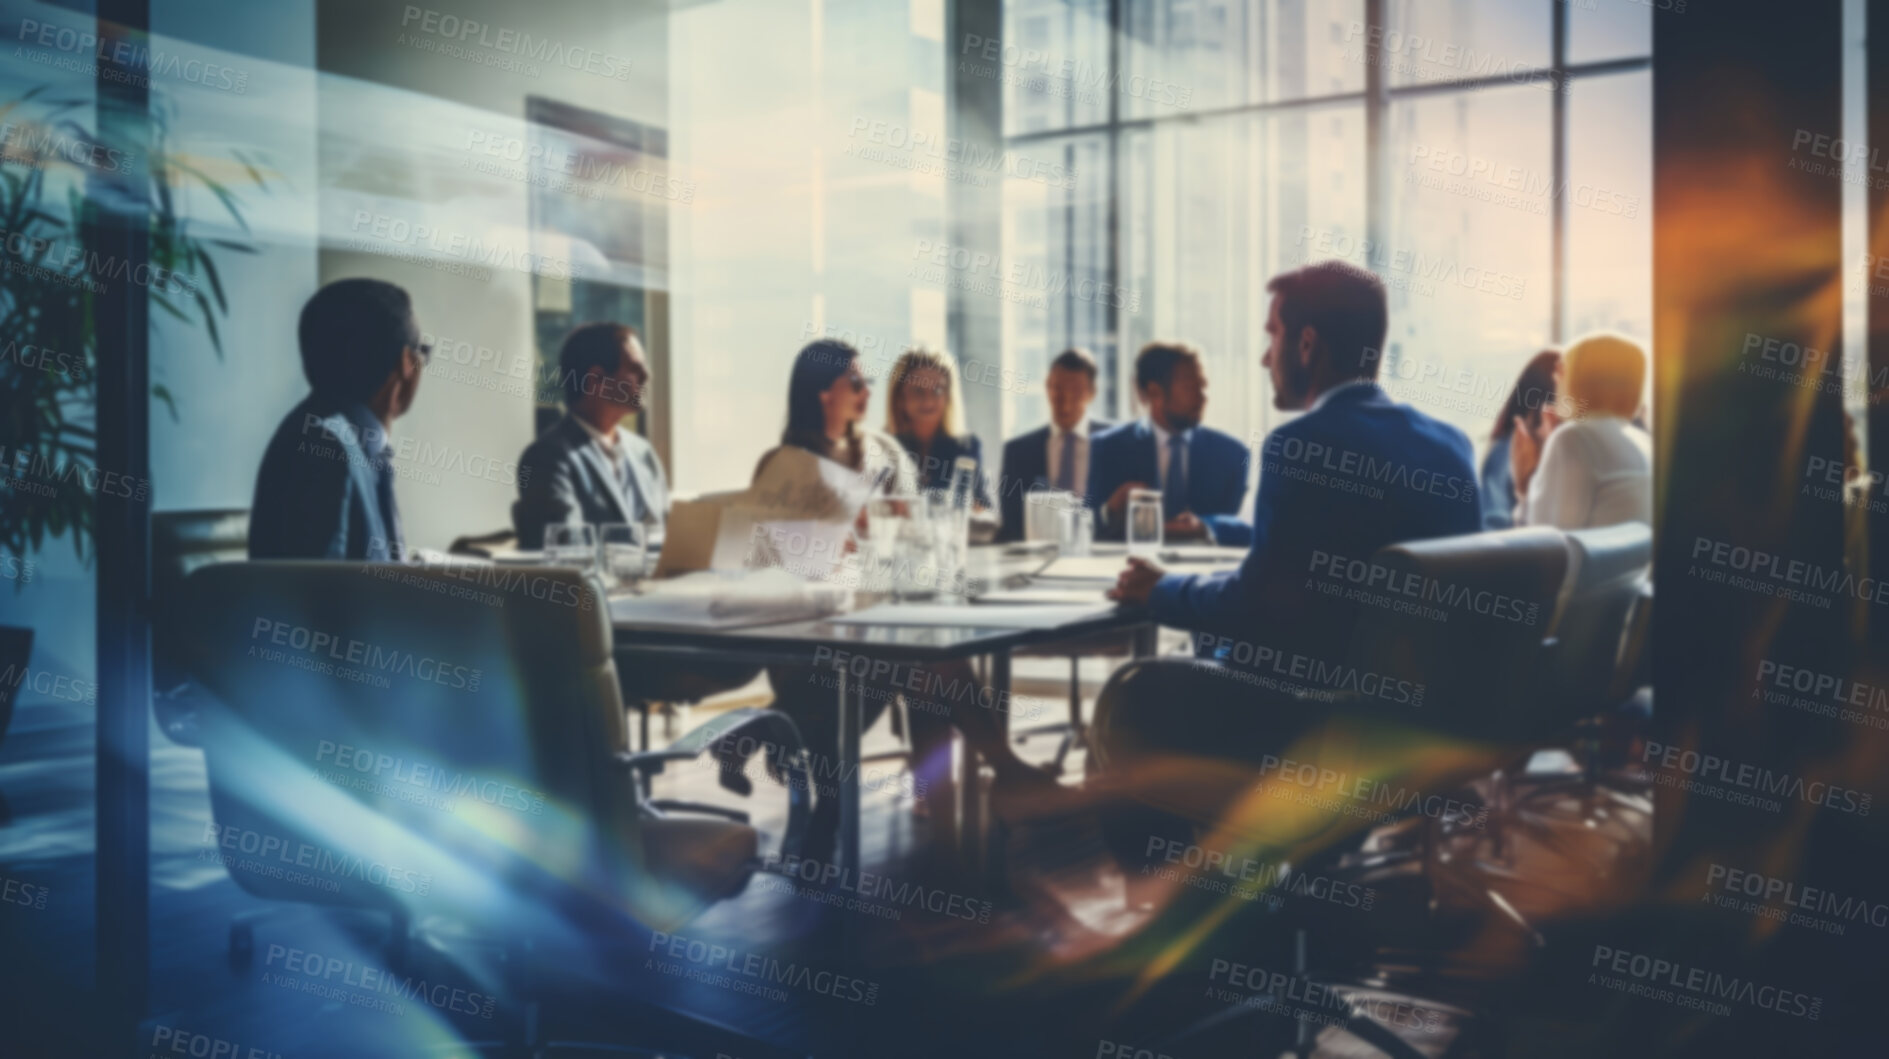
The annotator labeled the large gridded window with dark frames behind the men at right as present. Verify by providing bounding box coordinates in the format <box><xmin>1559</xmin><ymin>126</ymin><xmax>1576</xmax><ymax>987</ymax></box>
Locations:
<box><xmin>1003</xmin><ymin>0</ymin><xmax>1653</xmax><ymax>453</ymax></box>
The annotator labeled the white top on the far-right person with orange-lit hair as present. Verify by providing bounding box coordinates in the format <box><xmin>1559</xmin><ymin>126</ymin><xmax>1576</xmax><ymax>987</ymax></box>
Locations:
<box><xmin>1515</xmin><ymin>415</ymin><xmax>1653</xmax><ymax>530</ymax></box>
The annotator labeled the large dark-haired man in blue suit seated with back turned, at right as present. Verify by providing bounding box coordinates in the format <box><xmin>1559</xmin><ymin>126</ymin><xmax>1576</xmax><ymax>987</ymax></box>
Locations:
<box><xmin>1098</xmin><ymin>261</ymin><xmax>1481</xmax><ymax>866</ymax></box>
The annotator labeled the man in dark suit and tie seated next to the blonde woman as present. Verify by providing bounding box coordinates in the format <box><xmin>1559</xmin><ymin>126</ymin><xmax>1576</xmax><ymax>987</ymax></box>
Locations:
<box><xmin>997</xmin><ymin>349</ymin><xmax>1113</xmax><ymax>540</ymax></box>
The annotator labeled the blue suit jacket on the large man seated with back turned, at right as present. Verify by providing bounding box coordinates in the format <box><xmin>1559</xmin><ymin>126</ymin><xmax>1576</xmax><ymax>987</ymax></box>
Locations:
<box><xmin>1149</xmin><ymin>383</ymin><xmax>1481</xmax><ymax>663</ymax></box>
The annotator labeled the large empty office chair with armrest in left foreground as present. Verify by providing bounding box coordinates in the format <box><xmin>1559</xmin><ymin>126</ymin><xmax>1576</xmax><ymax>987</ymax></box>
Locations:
<box><xmin>183</xmin><ymin>563</ymin><xmax>808</xmax><ymax>1053</ymax></box>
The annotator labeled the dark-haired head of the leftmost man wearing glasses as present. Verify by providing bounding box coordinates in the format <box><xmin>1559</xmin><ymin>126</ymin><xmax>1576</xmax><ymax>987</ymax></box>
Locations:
<box><xmin>295</xmin><ymin>279</ymin><xmax>419</xmax><ymax>400</ymax></box>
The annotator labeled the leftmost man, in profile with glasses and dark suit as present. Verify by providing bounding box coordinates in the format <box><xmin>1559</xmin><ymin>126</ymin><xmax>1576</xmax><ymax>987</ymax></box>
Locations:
<box><xmin>249</xmin><ymin>279</ymin><xmax>431</xmax><ymax>563</ymax></box>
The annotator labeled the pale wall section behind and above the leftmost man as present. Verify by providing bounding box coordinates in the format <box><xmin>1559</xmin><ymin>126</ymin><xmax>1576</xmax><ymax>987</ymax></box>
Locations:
<box><xmin>317</xmin><ymin>0</ymin><xmax>667</xmax><ymax>549</ymax></box>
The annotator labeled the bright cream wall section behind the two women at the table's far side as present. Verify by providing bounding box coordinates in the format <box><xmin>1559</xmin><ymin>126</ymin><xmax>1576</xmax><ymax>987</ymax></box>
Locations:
<box><xmin>671</xmin><ymin>0</ymin><xmax>952</xmax><ymax>493</ymax></box>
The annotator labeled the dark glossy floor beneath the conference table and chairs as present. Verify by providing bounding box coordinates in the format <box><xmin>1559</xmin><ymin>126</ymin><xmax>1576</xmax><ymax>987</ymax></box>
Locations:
<box><xmin>0</xmin><ymin>661</ymin><xmax>1651</xmax><ymax>1059</ymax></box>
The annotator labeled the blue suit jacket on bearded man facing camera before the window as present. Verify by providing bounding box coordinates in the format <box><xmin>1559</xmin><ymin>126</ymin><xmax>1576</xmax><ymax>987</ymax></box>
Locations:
<box><xmin>1088</xmin><ymin>419</ymin><xmax>1252</xmax><ymax>547</ymax></box>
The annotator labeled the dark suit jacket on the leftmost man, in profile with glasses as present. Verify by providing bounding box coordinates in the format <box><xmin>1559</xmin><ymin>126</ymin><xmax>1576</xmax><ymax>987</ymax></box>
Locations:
<box><xmin>249</xmin><ymin>395</ymin><xmax>404</xmax><ymax>563</ymax></box>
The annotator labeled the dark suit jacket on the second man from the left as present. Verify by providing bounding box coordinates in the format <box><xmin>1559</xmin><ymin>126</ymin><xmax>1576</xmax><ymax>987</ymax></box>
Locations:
<box><xmin>512</xmin><ymin>415</ymin><xmax>669</xmax><ymax>547</ymax></box>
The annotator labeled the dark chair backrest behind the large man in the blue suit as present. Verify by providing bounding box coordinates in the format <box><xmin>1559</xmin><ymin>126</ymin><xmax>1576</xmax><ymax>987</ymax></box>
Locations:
<box><xmin>1351</xmin><ymin>527</ymin><xmax>1568</xmax><ymax>740</ymax></box>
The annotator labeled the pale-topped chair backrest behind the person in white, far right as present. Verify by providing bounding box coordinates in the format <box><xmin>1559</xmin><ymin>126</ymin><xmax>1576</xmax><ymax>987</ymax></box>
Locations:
<box><xmin>1543</xmin><ymin>523</ymin><xmax>1653</xmax><ymax>721</ymax></box>
